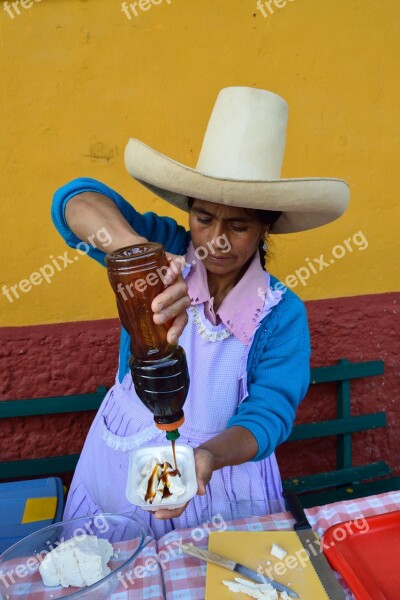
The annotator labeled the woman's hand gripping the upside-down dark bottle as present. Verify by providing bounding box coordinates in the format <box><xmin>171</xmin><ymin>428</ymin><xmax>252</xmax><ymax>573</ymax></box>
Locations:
<box><xmin>151</xmin><ymin>252</ymin><xmax>190</xmax><ymax>344</ymax></box>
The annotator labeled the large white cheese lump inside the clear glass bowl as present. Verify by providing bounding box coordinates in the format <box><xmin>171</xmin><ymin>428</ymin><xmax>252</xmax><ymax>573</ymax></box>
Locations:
<box><xmin>39</xmin><ymin>535</ymin><xmax>114</xmax><ymax>587</ymax></box>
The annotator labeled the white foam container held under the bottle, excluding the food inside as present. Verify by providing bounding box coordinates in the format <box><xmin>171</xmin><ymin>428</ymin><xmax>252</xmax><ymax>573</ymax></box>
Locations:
<box><xmin>126</xmin><ymin>443</ymin><xmax>197</xmax><ymax>512</ymax></box>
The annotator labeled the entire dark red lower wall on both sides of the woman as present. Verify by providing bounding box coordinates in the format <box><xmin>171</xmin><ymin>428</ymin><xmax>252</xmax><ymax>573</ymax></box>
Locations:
<box><xmin>0</xmin><ymin>293</ymin><xmax>400</xmax><ymax>477</ymax></box>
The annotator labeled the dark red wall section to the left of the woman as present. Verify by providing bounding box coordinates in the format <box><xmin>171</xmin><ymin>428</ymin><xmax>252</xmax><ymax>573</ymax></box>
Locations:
<box><xmin>0</xmin><ymin>319</ymin><xmax>119</xmax><ymax>461</ymax></box>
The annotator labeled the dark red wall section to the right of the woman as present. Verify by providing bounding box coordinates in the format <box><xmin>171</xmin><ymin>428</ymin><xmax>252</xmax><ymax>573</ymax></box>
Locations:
<box><xmin>277</xmin><ymin>293</ymin><xmax>400</xmax><ymax>477</ymax></box>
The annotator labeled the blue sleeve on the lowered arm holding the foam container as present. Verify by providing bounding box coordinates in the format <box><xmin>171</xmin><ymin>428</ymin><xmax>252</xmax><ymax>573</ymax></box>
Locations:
<box><xmin>228</xmin><ymin>290</ymin><xmax>310</xmax><ymax>461</ymax></box>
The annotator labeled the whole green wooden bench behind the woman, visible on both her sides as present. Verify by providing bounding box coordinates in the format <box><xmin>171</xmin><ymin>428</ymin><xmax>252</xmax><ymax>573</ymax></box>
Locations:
<box><xmin>0</xmin><ymin>359</ymin><xmax>400</xmax><ymax>507</ymax></box>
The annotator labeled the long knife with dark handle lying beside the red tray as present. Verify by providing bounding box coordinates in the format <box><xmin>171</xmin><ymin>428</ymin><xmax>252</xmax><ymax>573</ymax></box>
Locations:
<box><xmin>283</xmin><ymin>491</ymin><xmax>346</xmax><ymax>600</ymax></box>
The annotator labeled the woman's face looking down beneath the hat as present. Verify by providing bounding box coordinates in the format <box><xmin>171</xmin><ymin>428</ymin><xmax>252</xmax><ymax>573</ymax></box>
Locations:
<box><xmin>189</xmin><ymin>199</ymin><xmax>269</xmax><ymax>275</ymax></box>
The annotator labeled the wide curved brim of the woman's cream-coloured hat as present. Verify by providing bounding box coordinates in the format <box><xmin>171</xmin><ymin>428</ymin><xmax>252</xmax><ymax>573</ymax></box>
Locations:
<box><xmin>125</xmin><ymin>138</ymin><xmax>350</xmax><ymax>233</ymax></box>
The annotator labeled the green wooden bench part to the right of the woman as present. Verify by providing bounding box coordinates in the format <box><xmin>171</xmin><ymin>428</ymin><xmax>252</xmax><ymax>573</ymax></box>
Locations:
<box><xmin>283</xmin><ymin>359</ymin><xmax>400</xmax><ymax>508</ymax></box>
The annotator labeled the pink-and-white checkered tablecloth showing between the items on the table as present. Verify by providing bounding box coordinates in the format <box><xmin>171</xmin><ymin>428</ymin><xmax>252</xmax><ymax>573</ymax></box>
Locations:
<box><xmin>116</xmin><ymin>491</ymin><xmax>400</xmax><ymax>600</ymax></box>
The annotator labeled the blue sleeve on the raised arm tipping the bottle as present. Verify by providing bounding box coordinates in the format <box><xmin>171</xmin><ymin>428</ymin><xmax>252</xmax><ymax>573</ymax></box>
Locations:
<box><xmin>51</xmin><ymin>177</ymin><xmax>190</xmax><ymax>265</ymax></box>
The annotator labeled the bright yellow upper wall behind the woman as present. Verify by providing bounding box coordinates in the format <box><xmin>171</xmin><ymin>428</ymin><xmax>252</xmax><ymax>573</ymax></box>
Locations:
<box><xmin>0</xmin><ymin>0</ymin><xmax>400</xmax><ymax>326</ymax></box>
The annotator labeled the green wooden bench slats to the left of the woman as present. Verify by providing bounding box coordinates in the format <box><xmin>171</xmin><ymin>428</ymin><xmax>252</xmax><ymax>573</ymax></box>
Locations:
<box><xmin>0</xmin><ymin>387</ymin><xmax>107</xmax><ymax>480</ymax></box>
